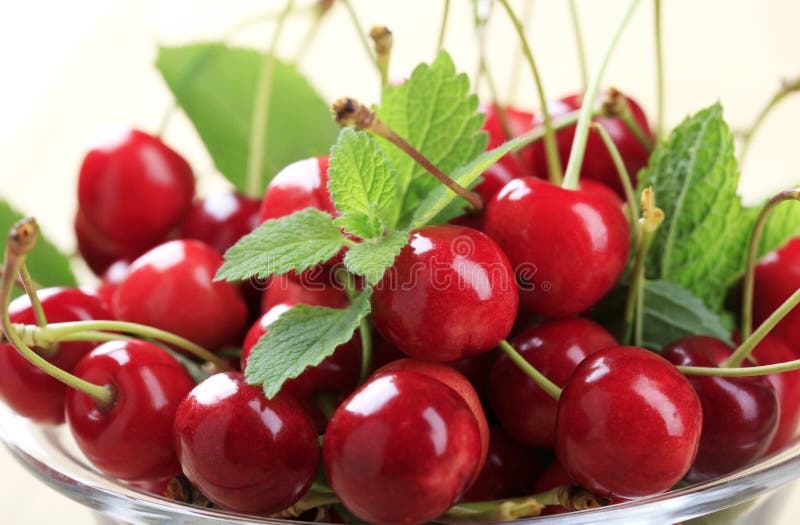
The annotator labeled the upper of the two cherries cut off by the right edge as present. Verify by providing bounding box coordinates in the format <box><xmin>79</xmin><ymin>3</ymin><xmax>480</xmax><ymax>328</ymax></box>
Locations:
<box><xmin>753</xmin><ymin>237</ymin><xmax>800</xmax><ymax>356</ymax></box>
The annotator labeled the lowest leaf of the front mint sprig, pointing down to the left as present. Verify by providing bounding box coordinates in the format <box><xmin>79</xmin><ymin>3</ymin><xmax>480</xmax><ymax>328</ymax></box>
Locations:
<box><xmin>246</xmin><ymin>288</ymin><xmax>372</xmax><ymax>399</ymax></box>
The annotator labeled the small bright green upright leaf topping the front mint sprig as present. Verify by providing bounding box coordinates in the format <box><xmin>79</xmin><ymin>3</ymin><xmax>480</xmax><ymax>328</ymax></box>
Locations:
<box><xmin>328</xmin><ymin>129</ymin><xmax>400</xmax><ymax>239</ymax></box>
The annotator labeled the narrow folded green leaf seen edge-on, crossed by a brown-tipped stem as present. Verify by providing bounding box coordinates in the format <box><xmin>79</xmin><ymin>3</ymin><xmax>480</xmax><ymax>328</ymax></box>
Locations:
<box><xmin>409</xmin><ymin>133</ymin><xmax>532</xmax><ymax>230</ymax></box>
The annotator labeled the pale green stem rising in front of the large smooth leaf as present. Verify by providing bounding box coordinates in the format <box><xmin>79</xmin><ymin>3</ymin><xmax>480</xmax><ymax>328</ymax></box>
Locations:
<box><xmin>246</xmin><ymin>0</ymin><xmax>294</xmax><ymax>197</ymax></box>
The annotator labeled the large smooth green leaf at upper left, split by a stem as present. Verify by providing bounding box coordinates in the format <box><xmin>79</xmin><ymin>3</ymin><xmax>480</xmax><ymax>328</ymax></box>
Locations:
<box><xmin>156</xmin><ymin>43</ymin><xmax>338</xmax><ymax>192</ymax></box>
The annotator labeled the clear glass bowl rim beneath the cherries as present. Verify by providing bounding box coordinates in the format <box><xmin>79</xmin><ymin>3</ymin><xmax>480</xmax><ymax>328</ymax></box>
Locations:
<box><xmin>0</xmin><ymin>403</ymin><xmax>800</xmax><ymax>525</ymax></box>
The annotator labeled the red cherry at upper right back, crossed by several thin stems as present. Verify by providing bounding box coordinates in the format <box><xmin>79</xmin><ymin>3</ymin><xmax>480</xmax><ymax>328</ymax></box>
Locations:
<box><xmin>531</xmin><ymin>93</ymin><xmax>653</xmax><ymax>196</ymax></box>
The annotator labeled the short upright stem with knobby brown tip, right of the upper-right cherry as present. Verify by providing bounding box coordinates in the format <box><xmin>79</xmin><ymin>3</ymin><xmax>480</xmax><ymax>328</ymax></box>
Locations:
<box><xmin>622</xmin><ymin>188</ymin><xmax>664</xmax><ymax>346</ymax></box>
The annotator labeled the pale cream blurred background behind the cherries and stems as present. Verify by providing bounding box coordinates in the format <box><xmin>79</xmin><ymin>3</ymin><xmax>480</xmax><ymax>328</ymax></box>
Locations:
<box><xmin>0</xmin><ymin>0</ymin><xmax>800</xmax><ymax>524</ymax></box>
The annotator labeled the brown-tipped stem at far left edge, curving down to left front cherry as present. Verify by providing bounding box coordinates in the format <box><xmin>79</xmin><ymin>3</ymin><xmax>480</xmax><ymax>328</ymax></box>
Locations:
<box><xmin>0</xmin><ymin>218</ymin><xmax>114</xmax><ymax>407</ymax></box>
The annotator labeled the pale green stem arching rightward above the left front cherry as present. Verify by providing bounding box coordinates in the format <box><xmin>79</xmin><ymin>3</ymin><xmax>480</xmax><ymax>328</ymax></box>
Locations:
<box><xmin>39</xmin><ymin>320</ymin><xmax>230</xmax><ymax>371</ymax></box>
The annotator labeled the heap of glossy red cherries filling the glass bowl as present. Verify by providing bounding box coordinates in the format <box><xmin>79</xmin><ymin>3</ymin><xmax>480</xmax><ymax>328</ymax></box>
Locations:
<box><xmin>0</xmin><ymin>91</ymin><xmax>800</xmax><ymax>524</ymax></box>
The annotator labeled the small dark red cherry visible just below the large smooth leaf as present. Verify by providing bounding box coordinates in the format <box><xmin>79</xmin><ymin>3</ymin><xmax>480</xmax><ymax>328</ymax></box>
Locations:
<box><xmin>178</xmin><ymin>191</ymin><xmax>261</xmax><ymax>253</ymax></box>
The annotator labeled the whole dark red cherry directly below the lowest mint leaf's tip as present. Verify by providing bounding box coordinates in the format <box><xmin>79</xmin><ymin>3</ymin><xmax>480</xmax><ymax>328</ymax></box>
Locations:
<box><xmin>174</xmin><ymin>372</ymin><xmax>320</xmax><ymax>514</ymax></box>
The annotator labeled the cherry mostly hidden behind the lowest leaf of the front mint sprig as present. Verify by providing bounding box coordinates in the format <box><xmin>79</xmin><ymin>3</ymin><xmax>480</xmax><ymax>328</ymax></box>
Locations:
<box><xmin>242</xmin><ymin>303</ymin><xmax>361</xmax><ymax>403</ymax></box>
